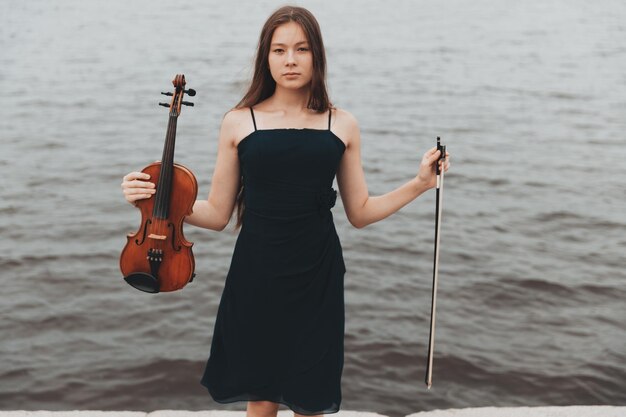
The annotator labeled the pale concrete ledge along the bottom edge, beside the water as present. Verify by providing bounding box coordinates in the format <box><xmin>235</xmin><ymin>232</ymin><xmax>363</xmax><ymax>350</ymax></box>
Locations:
<box><xmin>0</xmin><ymin>405</ymin><xmax>626</xmax><ymax>417</ymax></box>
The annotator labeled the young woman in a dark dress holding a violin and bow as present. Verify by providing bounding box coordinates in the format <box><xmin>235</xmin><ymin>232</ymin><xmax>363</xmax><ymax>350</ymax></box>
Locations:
<box><xmin>122</xmin><ymin>6</ymin><xmax>450</xmax><ymax>417</ymax></box>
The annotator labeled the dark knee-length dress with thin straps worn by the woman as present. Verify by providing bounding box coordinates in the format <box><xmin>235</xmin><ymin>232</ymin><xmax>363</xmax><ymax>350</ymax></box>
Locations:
<box><xmin>200</xmin><ymin>109</ymin><xmax>346</xmax><ymax>415</ymax></box>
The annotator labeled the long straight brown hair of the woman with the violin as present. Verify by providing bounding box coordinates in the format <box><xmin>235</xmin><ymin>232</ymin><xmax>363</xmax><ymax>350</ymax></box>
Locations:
<box><xmin>229</xmin><ymin>6</ymin><xmax>334</xmax><ymax>230</ymax></box>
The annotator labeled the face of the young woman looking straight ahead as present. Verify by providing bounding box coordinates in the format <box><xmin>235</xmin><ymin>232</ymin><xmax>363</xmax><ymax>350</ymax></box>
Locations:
<box><xmin>268</xmin><ymin>21</ymin><xmax>313</xmax><ymax>89</ymax></box>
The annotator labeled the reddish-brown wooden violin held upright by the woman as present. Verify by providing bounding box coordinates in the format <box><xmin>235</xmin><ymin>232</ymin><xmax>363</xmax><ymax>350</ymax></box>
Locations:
<box><xmin>120</xmin><ymin>74</ymin><xmax>198</xmax><ymax>293</ymax></box>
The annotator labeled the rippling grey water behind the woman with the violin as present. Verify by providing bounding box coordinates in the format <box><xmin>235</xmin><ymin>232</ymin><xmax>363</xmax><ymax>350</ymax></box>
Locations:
<box><xmin>0</xmin><ymin>0</ymin><xmax>626</xmax><ymax>416</ymax></box>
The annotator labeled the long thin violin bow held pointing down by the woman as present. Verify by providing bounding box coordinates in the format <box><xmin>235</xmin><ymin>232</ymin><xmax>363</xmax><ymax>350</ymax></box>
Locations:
<box><xmin>426</xmin><ymin>136</ymin><xmax>446</xmax><ymax>389</ymax></box>
